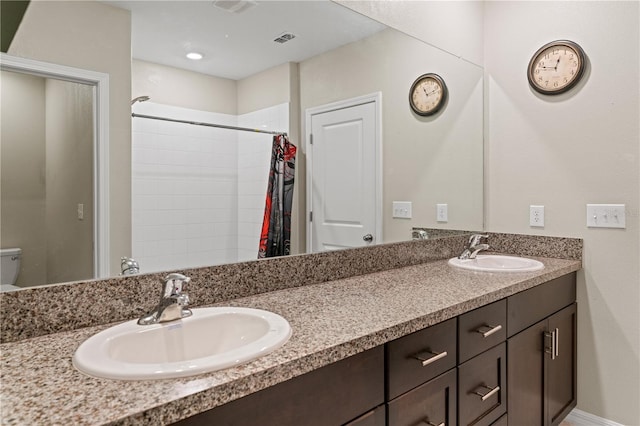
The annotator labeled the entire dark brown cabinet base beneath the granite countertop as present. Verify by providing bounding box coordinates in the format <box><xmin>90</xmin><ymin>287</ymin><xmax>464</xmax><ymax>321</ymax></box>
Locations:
<box><xmin>172</xmin><ymin>273</ymin><xmax>577</xmax><ymax>426</ymax></box>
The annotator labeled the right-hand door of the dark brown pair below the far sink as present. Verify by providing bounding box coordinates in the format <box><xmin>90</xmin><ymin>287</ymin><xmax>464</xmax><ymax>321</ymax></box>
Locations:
<box><xmin>545</xmin><ymin>303</ymin><xmax>577</xmax><ymax>426</ymax></box>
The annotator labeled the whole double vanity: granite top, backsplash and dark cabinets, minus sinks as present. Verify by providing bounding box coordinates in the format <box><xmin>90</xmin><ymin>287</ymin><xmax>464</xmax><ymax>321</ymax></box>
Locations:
<box><xmin>0</xmin><ymin>234</ymin><xmax>582</xmax><ymax>426</ymax></box>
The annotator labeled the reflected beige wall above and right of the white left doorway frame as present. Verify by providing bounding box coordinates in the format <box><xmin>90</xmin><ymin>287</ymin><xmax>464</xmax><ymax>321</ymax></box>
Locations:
<box><xmin>8</xmin><ymin>1</ymin><xmax>131</xmax><ymax>275</ymax></box>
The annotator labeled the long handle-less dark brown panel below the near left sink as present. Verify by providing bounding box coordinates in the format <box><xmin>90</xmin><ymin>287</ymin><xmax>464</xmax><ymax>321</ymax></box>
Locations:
<box><xmin>175</xmin><ymin>346</ymin><xmax>384</xmax><ymax>426</ymax></box>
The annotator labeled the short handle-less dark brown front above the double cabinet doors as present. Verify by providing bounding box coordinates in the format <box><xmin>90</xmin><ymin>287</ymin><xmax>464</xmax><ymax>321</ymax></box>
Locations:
<box><xmin>507</xmin><ymin>272</ymin><xmax>576</xmax><ymax>337</ymax></box>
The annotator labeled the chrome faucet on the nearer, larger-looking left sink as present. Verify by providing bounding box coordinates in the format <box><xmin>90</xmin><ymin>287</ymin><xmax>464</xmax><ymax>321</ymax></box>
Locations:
<box><xmin>138</xmin><ymin>274</ymin><xmax>192</xmax><ymax>325</ymax></box>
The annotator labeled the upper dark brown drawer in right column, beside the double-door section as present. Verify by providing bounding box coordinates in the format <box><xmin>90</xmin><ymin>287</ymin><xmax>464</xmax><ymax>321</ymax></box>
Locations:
<box><xmin>458</xmin><ymin>299</ymin><xmax>507</xmax><ymax>363</ymax></box>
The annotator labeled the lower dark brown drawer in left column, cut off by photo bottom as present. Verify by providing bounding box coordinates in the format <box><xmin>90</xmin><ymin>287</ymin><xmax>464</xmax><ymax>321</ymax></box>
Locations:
<box><xmin>388</xmin><ymin>368</ymin><xmax>456</xmax><ymax>426</ymax></box>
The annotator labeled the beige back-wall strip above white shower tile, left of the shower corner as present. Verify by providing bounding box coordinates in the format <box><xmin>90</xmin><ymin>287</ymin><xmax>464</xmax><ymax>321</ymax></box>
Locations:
<box><xmin>131</xmin><ymin>60</ymin><xmax>238</xmax><ymax>114</ymax></box>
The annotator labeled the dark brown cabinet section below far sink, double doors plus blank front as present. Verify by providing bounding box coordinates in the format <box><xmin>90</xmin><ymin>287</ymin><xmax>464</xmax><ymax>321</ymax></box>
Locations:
<box><xmin>507</xmin><ymin>275</ymin><xmax>577</xmax><ymax>426</ymax></box>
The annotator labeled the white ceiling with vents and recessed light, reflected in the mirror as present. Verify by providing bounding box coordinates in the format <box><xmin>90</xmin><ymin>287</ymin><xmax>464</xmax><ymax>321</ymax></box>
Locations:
<box><xmin>103</xmin><ymin>0</ymin><xmax>385</xmax><ymax>80</ymax></box>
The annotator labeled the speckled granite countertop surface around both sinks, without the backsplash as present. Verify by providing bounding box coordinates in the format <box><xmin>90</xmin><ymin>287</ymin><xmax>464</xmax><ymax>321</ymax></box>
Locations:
<box><xmin>0</xmin><ymin>257</ymin><xmax>581</xmax><ymax>425</ymax></box>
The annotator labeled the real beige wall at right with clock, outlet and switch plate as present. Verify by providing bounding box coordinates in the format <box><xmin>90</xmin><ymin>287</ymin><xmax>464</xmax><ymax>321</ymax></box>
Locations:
<box><xmin>484</xmin><ymin>1</ymin><xmax>640</xmax><ymax>425</ymax></box>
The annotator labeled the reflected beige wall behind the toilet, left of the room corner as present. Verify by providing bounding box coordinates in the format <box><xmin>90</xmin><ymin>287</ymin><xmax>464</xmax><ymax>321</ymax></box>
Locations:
<box><xmin>0</xmin><ymin>71</ymin><xmax>47</xmax><ymax>286</ymax></box>
